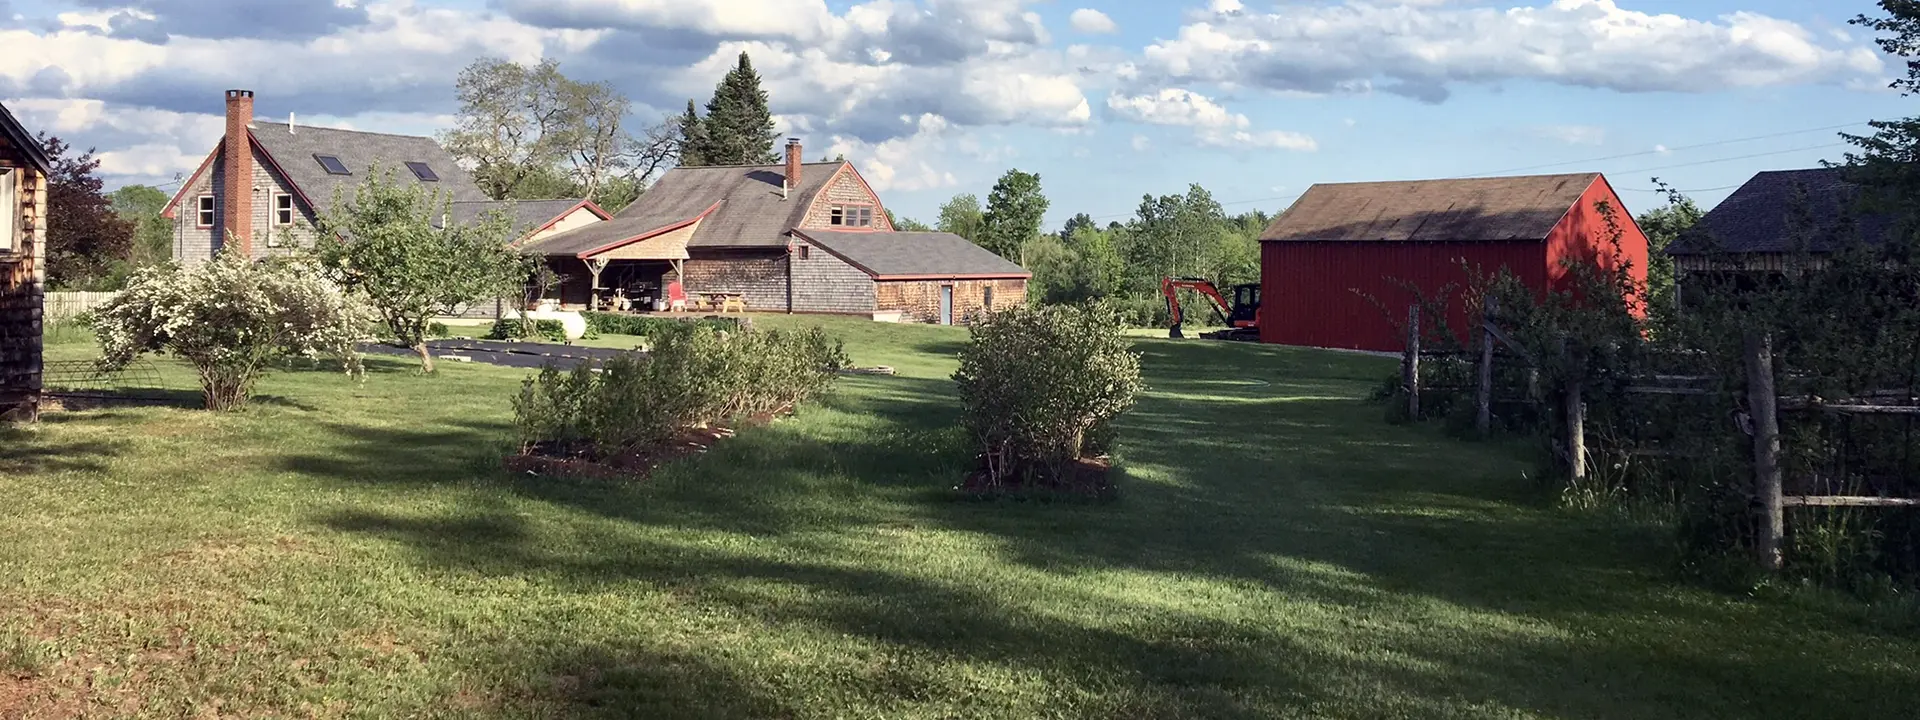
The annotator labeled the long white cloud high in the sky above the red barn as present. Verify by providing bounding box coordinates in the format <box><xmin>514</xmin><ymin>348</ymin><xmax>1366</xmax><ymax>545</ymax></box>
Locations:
<box><xmin>1140</xmin><ymin>0</ymin><xmax>1884</xmax><ymax>102</ymax></box>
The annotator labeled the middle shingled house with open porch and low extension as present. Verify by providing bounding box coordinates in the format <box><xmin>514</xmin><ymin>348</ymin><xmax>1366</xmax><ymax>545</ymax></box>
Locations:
<box><xmin>526</xmin><ymin>140</ymin><xmax>1031</xmax><ymax>324</ymax></box>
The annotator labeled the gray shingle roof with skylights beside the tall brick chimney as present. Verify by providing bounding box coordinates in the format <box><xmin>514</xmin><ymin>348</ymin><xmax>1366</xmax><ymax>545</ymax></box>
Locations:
<box><xmin>253</xmin><ymin>123</ymin><xmax>488</xmax><ymax>211</ymax></box>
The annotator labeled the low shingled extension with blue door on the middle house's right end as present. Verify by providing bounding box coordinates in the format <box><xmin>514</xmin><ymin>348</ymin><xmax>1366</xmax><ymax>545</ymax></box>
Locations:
<box><xmin>793</xmin><ymin>230</ymin><xmax>1033</xmax><ymax>324</ymax></box>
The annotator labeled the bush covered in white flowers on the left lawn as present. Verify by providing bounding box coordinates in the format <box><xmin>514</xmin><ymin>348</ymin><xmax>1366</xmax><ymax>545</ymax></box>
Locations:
<box><xmin>92</xmin><ymin>253</ymin><xmax>374</xmax><ymax>411</ymax></box>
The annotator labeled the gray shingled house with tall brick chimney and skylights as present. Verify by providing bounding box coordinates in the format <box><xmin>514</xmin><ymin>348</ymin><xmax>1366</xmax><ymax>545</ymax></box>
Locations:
<box><xmin>165</xmin><ymin>90</ymin><xmax>611</xmax><ymax>265</ymax></box>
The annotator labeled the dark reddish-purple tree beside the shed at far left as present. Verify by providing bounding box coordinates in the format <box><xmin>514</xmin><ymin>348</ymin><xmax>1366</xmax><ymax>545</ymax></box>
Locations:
<box><xmin>40</xmin><ymin>132</ymin><xmax>134</xmax><ymax>290</ymax></box>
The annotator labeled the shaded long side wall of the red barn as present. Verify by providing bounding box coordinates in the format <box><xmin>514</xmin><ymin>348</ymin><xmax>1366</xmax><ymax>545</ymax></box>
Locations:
<box><xmin>1260</xmin><ymin>242</ymin><xmax>1548</xmax><ymax>351</ymax></box>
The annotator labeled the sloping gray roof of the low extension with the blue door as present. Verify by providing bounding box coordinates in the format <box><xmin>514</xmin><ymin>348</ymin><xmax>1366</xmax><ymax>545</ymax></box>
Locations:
<box><xmin>793</xmin><ymin>230</ymin><xmax>1033</xmax><ymax>278</ymax></box>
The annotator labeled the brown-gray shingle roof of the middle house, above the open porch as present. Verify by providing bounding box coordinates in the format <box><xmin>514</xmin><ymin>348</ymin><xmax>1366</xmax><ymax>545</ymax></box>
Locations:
<box><xmin>610</xmin><ymin>163</ymin><xmax>845</xmax><ymax>248</ymax></box>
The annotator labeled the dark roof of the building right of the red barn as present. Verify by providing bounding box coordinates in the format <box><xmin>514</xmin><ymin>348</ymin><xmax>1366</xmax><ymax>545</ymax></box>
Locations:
<box><xmin>1667</xmin><ymin>167</ymin><xmax>1893</xmax><ymax>255</ymax></box>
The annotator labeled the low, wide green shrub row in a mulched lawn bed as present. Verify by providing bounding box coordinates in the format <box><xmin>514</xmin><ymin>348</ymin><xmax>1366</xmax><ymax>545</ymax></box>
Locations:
<box><xmin>513</xmin><ymin>323</ymin><xmax>849</xmax><ymax>457</ymax></box>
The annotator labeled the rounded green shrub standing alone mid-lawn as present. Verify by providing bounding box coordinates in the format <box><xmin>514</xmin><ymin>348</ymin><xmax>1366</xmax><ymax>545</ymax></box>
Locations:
<box><xmin>954</xmin><ymin>305</ymin><xmax>1140</xmax><ymax>482</ymax></box>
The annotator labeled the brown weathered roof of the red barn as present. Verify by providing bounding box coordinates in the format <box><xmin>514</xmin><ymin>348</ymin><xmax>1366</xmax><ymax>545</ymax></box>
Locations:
<box><xmin>1260</xmin><ymin>173</ymin><xmax>1601</xmax><ymax>242</ymax></box>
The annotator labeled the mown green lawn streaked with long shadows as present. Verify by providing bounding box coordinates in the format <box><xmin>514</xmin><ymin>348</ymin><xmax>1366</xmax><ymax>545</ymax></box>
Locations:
<box><xmin>0</xmin><ymin>317</ymin><xmax>1920</xmax><ymax>718</ymax></box>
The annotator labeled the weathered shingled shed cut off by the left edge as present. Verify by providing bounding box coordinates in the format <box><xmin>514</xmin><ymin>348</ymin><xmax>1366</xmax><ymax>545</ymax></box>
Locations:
<box><xmin>0</xmin><ymin>106</ymin><xmax>52</xmax><ymax>420</ymax></box>
